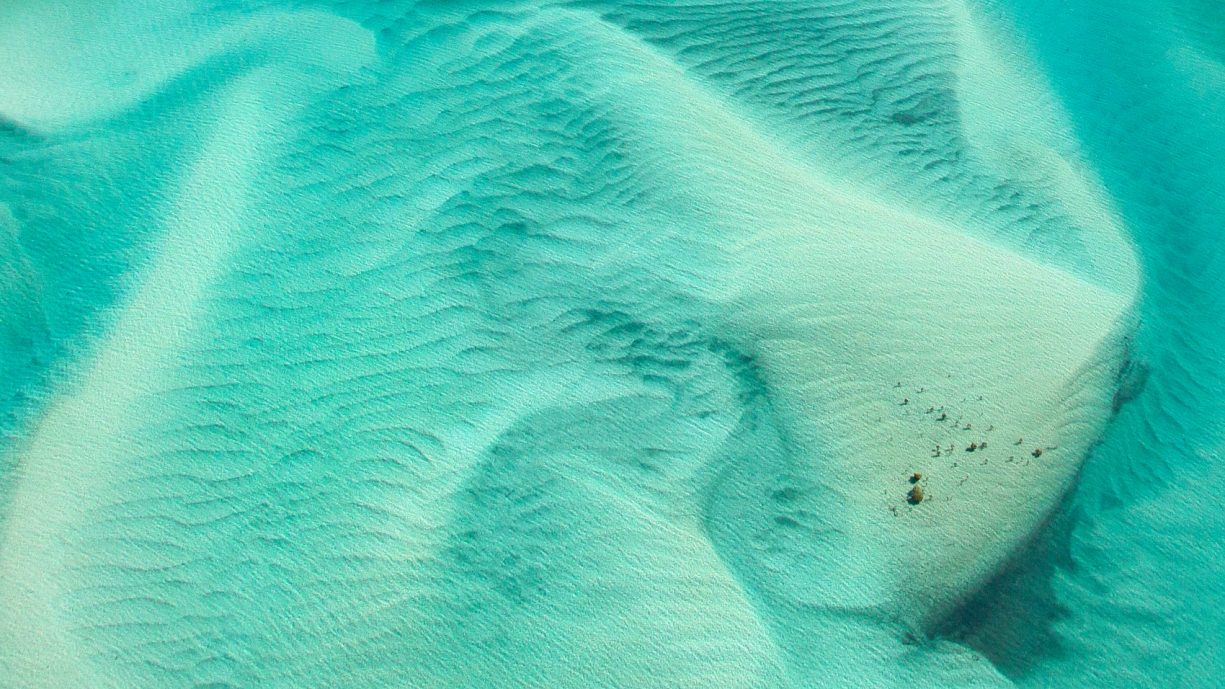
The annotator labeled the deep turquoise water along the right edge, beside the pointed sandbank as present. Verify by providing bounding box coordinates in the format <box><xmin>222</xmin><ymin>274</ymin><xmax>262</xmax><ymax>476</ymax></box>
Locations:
<box><xmin>955</xmin><ymin>1</ymin><xmax>1225</xmax><ymax>687</ymax></box>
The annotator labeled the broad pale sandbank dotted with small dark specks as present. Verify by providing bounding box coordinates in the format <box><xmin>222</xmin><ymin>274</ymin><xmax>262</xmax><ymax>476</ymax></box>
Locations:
<box><xmin>561</xmin><ymin>6</ymin><xmax>1138</xmax><ymax>624</ymax></box>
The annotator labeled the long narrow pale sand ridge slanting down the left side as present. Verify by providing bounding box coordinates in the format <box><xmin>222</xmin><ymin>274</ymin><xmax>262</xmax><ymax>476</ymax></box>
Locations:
<box><xmin>0</xmin><ymin>12</ymin><xmax>374</xmax><ymax>671</ymax></box>
